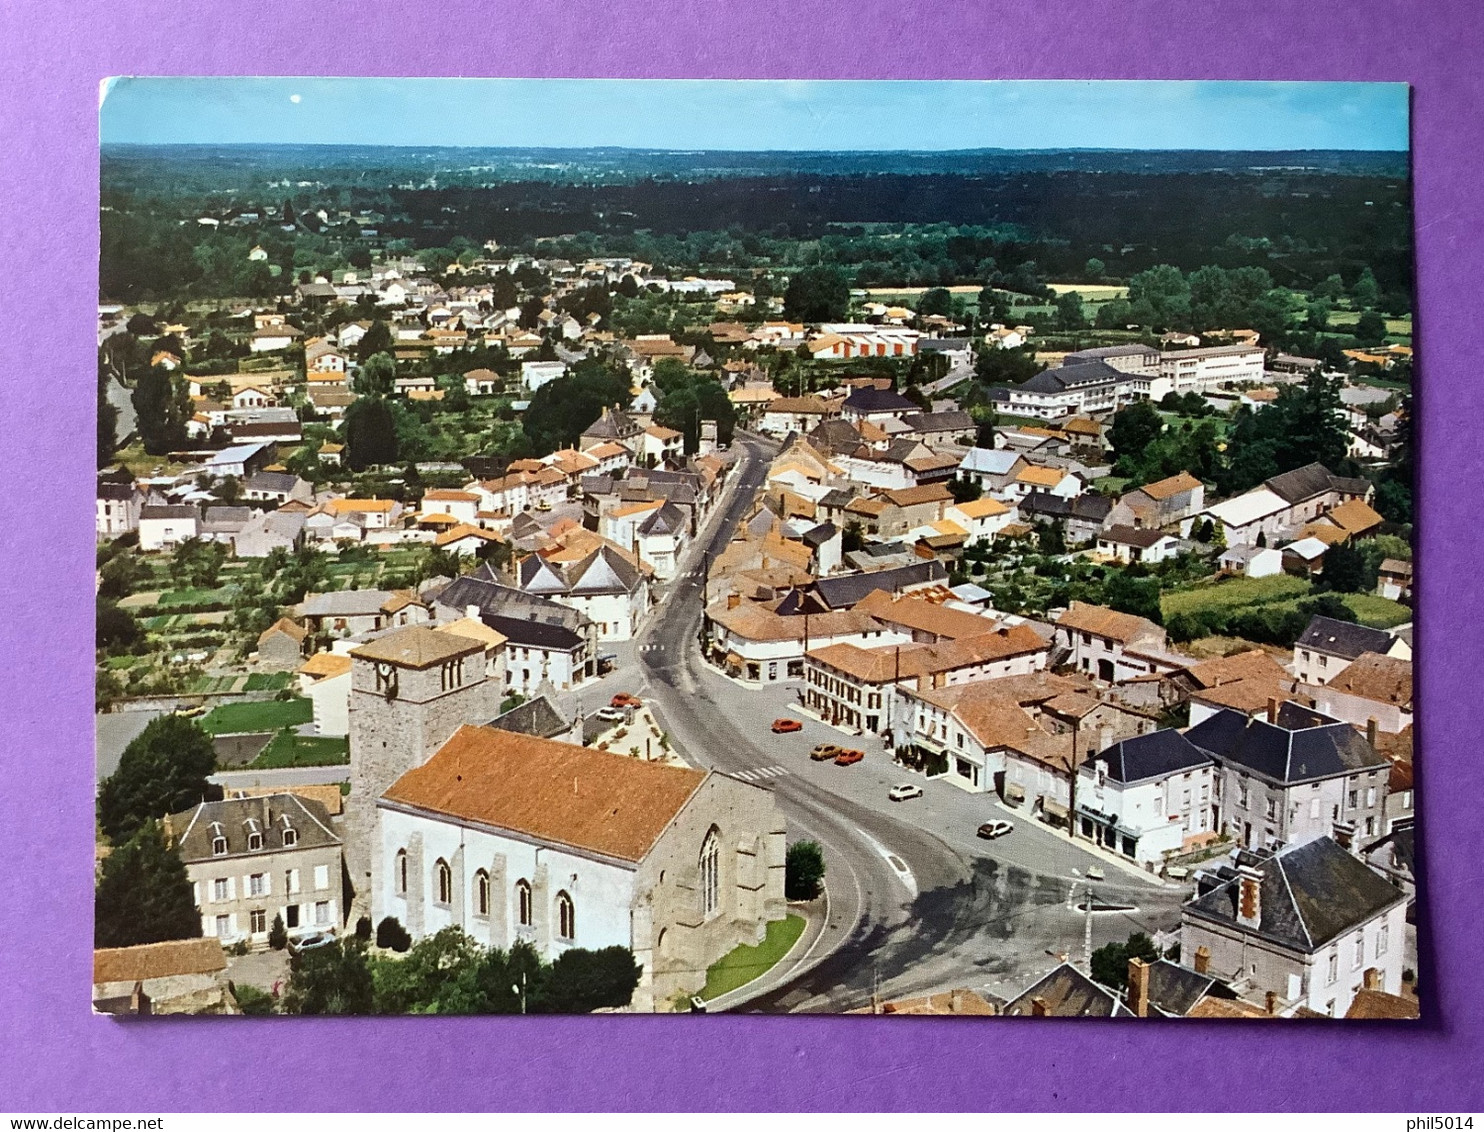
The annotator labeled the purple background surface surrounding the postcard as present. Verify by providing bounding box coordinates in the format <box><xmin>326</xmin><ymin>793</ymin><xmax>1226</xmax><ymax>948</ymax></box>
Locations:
<box><xmin>0</xmin><ymin>0</ymin><xmax>1484</xmax><ymax>1111</ymax></box>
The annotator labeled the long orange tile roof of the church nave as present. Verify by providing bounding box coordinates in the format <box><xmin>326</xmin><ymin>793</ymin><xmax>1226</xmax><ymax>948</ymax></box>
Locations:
<box><xmin>381</xmin><ymin>725</ymin><xmax>706</xmax><ymax>862</ymax></box>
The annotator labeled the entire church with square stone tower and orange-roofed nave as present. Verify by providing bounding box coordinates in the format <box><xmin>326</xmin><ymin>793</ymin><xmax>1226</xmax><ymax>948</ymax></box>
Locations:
<box><xmin>346</xmin><ymin>626</ymin><xmax>785</xmax><ymax>1010</ymax></box>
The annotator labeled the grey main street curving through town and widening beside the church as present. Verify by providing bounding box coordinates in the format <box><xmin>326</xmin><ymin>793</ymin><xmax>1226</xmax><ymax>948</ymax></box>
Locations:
<box><xmin>572</xmin><ymin>433</ymin><xmax>1184</xmax><ymax>1012</ymax></box>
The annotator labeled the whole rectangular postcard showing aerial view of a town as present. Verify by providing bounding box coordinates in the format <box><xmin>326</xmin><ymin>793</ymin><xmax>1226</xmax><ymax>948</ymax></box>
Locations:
<box><xmin>92</xmin><ymin>79</ymin><xmax>1426</xmax><ymax>1019</ymax></box>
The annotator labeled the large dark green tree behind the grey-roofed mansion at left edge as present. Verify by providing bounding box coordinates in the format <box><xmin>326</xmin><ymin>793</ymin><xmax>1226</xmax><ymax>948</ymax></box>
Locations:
<box><xmin>98</xmin><ymin>714</ymin><xmax>217</xmax><ymax>844</ymax></box>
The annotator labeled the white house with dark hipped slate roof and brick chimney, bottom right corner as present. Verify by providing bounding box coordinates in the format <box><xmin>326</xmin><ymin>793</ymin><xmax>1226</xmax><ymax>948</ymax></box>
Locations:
<box><xmin>1180</xmin><ymin>837</ymin><xmax>1407</xmax><ymax>1018</ymax></box>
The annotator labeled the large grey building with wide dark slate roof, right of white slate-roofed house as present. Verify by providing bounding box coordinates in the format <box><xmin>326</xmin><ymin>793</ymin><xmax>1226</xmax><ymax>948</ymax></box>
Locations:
<box><xmin>1186</xmin><ymin>702</ymin><xmax>1391</xmax><ymax>849</ymax></box>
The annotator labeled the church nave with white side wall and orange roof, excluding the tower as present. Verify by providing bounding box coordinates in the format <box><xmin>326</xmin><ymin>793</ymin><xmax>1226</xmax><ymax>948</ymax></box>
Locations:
<box><xmin>372</xmin><ymin>727</ymin><xmax>787</xmax><ymax>1010</ymax></box>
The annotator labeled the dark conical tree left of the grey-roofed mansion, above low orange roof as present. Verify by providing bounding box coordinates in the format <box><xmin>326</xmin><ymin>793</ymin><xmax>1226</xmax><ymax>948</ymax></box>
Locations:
<box><xmin>93</xmin><ymin>822</ymin><xmax>200</xmax><ymax>947</ymax></box>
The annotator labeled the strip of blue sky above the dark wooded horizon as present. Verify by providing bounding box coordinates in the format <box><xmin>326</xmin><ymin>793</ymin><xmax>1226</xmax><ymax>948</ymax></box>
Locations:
<box><xmin>99</xmin><ymin>79</ymin><xmax>1408</xmax><ymax>150</ymax></box>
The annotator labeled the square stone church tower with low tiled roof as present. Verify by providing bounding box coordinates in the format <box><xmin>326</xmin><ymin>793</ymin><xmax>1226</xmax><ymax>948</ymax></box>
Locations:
<box><xmin>346</xmin><ymin>625</ymin><xmax>500</xmax><ymax>915</ymax></box>
